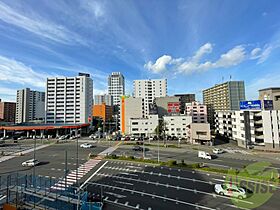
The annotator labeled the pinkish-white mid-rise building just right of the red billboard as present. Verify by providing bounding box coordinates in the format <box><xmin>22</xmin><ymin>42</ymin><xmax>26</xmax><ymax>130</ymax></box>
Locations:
<box><xmin>185</xmin><ymin>101</ymin><xmax>207</xmax><ymax>123</ymax></box>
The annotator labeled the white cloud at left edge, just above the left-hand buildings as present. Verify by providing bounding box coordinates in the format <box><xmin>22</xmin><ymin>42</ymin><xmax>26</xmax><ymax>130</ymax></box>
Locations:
<box><xmin>0</xmin><ymin>55</ymin><xmax>51</xmax><ymax>88</ymax></box>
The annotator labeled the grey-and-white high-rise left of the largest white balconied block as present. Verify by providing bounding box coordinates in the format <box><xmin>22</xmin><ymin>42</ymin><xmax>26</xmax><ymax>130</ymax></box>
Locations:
<box><xmin>16</xmin><ymin>88</ymin><xmax>45</xmax><ymax>123</ymax></box>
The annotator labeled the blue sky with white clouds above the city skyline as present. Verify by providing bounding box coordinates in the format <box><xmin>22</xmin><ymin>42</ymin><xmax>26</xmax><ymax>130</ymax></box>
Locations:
<box><xmin>0</xmin><ymin>0</ymin><xmax>280</xmax><ymax>101</ymax></box>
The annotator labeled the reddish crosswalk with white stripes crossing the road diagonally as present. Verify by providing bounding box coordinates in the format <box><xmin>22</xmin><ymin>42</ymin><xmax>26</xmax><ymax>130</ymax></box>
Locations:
<box><xmin>51</xmin><ymin>158</ymin><xmax>101</xmax><ymax>190</ymax></box>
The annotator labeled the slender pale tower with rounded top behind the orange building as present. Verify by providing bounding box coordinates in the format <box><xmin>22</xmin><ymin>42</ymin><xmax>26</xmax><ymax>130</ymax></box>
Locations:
<box><xmin>108</xmin><ymin>72</ymin><xmax>125</xmax><ymax>105</ymax></box>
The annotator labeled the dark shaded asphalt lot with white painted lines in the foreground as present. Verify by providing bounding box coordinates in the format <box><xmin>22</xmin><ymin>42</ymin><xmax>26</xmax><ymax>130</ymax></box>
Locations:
<box><xmin>86</xmin><ymin>161</ymin><xmax>279</xmax><ymax>210</ymax></box>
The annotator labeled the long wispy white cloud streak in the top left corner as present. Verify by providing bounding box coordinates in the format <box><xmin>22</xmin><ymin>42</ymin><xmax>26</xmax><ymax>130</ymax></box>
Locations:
<box><xmin>0</xmin><ymin>3</ymin><xmax>86</xmax><ymax>45</ymax></box>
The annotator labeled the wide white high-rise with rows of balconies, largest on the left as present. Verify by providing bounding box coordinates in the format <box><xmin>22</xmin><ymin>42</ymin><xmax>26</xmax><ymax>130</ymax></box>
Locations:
<box><xmin>46</xmin><ymin>73</ymin><xmax>93</xmax><ymax>124</ymax></box>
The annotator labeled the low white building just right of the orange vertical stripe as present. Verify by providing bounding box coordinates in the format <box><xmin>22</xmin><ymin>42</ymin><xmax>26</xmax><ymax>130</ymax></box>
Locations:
<box><xmin>128</xmin><ymin>115</ymin><xmax>159</xmax><ymax>137</ymax></box>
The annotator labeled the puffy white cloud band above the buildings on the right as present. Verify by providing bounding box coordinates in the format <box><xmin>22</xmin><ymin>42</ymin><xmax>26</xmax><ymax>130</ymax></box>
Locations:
<box><xmin>144</xmin><ymin>43</ymin><xmax>273</xmax><ymax>74</ymax></box>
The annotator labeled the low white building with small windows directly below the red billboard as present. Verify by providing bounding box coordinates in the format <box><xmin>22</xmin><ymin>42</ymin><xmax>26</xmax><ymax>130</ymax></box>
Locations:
<box><xmin>163</xmin><ymin>115</ymin><xmax>192</xmax><ymax>139</ymax></box>
